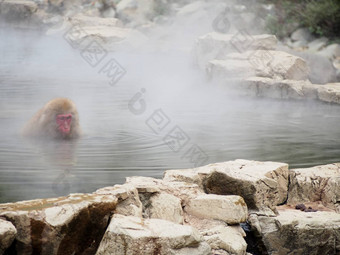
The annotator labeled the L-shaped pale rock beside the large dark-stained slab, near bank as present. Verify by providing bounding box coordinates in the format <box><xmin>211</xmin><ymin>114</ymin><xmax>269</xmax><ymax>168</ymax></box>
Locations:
<box><xmin>95</xmin><ymin>184</ymin><xmax>143</xmax><ymax>217</ymax></box>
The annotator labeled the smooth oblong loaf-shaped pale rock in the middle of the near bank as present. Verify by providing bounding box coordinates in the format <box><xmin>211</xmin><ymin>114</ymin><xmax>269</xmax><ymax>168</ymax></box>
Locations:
<box><xmin>185</xmin><ymin>194</ymin><xmax>248</xmax><ymax>224</ymax></box>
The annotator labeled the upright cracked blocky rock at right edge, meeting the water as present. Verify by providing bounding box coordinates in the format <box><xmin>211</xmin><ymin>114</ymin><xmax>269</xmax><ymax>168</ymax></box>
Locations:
<box><xmin>287</xmin><ymin>162</ymin><xmax>340</xmax><ymax>213</ymax></box>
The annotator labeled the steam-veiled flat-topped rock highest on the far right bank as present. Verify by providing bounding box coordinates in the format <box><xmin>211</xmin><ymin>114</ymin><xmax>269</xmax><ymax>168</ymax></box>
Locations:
<box><xmin>193</xmin><ymin>32</ymin><xmax>277</xmax><ymax>69</ymax></box>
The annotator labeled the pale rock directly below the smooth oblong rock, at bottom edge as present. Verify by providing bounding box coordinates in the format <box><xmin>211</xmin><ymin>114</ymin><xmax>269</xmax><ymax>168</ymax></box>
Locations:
<box><xmin>202</xmin><ymin>226</ymin><xmax>247</xmax><ymax>255</ymax></box>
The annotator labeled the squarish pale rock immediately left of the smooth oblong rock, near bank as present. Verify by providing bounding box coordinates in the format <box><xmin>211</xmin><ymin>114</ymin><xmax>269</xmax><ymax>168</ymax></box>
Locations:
<box><xmin>148</xmin><ymin>193</ymin><xmax>183</xmax><ymax>224</ymax></box>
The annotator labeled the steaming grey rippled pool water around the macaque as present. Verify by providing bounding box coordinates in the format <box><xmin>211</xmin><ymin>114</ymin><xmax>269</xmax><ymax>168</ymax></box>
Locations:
<box><xmin>0</xmin><ymin>30</ymin><xmax>340</xmax><ymax>202</ymax></box>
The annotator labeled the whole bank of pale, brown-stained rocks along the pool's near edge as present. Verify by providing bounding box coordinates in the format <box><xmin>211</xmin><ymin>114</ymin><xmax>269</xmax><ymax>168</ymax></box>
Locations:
<box><xmin>0</xmin><ymin>160</ymin><xmax>340</xmax><ymax>255</ymax></box>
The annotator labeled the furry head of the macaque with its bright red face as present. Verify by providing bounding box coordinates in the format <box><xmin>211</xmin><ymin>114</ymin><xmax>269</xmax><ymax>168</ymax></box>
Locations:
<box><xmin>40</xmin><ymin>98</ymin><xmax>79</xmax><ymax>139</ymax></box>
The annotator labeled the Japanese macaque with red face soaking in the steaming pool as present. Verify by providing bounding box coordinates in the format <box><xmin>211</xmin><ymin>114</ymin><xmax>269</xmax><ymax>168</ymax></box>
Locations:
<box><xmin>22</xmin><ymin>98</ymin><xmax>81</xmax><ymax>139</ymax></box>
